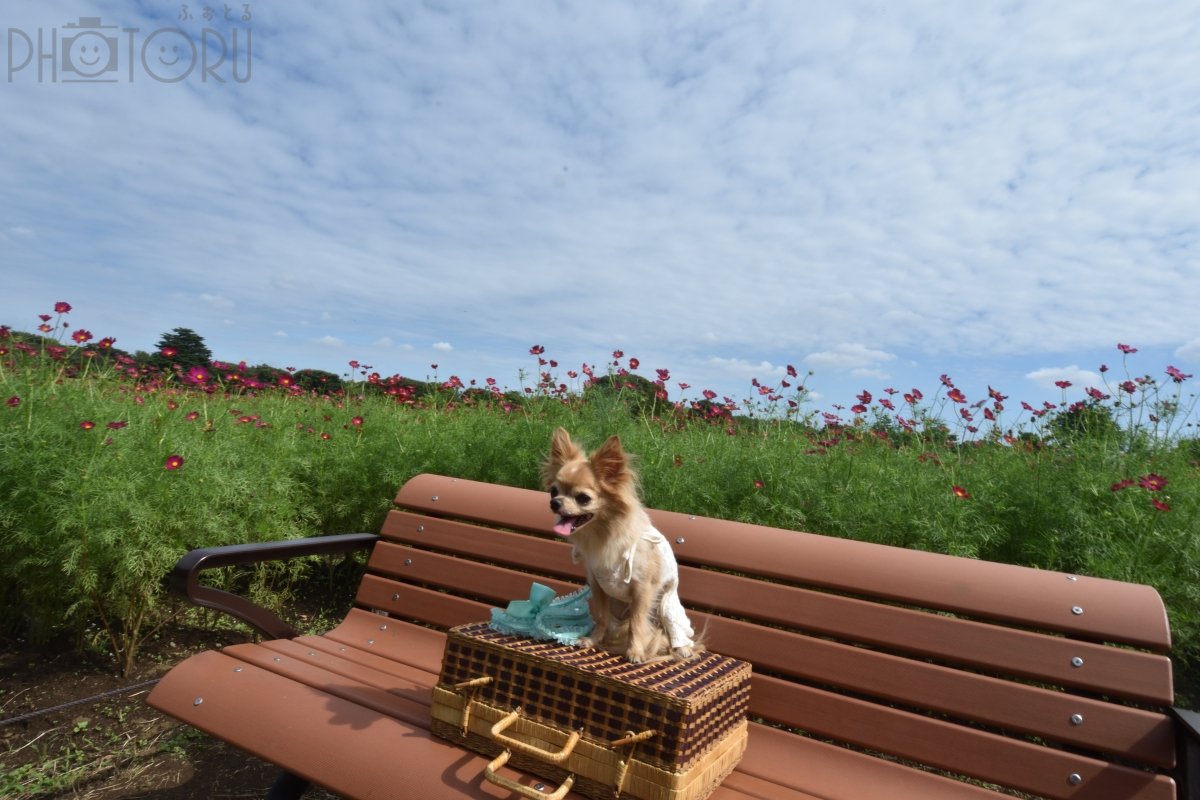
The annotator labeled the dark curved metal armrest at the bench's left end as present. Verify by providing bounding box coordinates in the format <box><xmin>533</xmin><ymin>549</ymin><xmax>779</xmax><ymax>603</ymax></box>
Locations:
<box><xmin>168</xmin><ymin>534</ymin><xmax>379</xmax><ymax>639</ymax></box>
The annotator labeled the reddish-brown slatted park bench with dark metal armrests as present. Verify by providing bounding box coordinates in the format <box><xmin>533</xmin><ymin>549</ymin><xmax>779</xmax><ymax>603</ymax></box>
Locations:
<box><xmin>149</xmin><ymin>475</ymin><xmax>1200</xmax><ymax>800</ymax></box>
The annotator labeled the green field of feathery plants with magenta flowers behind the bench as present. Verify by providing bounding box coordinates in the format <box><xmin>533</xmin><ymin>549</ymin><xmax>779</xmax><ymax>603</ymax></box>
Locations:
<box><xmin>0</xmin><ymin>303</ymin><xmax>1200</xmax><ymax>705</ymax></box>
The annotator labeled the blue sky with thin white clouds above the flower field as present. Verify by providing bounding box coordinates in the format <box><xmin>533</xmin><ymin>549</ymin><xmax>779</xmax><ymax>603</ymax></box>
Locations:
<box><xmin>0</xmin><ymin>0</ymin><xmax>1200</xmax><ymax>424</ymax></box>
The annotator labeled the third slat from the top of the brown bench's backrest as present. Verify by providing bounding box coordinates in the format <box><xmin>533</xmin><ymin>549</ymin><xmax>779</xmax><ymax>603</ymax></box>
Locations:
<box><xmin>371</xmin><ymin>542</ymin><xmax>1176</xmax><ymax>768</ymax></box>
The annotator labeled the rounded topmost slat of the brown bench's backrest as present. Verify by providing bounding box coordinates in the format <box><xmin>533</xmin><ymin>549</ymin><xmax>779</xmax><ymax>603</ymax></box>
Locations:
<box><xmin>396</xmin><ymin>475</ymin><xmax>1171</xmax><ymax>652</ymax></box>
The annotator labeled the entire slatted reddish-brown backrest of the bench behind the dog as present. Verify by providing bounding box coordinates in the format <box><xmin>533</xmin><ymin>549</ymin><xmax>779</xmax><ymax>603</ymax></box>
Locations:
<box><xmin>384</xmin><ymin>476</ymin><xmax>1176</xmax><ymax>800</ymax></box>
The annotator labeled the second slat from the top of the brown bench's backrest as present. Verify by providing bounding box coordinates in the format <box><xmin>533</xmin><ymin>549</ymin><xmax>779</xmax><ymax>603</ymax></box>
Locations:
<box><xmin>374</xmin><ymin>512</ymin><xmax>1174</xmax><ymax>705</ymax></box>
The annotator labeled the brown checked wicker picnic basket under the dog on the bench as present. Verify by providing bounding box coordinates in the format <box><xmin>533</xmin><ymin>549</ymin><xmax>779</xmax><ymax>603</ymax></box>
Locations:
<box><xmin>432</xmin><ymin>622</ymin><xmax>750</xmax><ymax>800</ymax></box>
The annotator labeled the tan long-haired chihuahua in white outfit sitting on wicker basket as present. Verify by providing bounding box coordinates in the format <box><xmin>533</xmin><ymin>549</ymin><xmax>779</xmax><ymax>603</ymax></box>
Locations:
<box><xmin>541</xmin><ymin>428</ymin><xmax>701</xmax><ymax>662</ymax></box>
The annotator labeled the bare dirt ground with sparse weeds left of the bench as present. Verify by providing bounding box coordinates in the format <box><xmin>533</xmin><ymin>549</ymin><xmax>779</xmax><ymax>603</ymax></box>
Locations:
<box><xmin>0</xmin><ymin>626</ymin><xmax>348</xmax><ymax>800</ymax></box>
